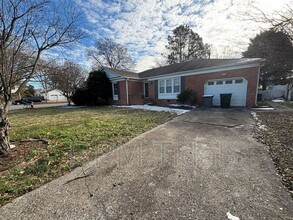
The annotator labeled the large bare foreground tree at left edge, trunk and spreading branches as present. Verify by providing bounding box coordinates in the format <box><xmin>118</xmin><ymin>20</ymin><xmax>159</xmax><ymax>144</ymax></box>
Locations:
<box><xmin>0</xmin><ymin>0</ymin><xmax>82</xmax><ymax>154</ymax></box>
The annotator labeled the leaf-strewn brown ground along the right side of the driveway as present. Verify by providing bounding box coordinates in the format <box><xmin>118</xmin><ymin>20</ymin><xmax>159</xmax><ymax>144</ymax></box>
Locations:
<box><xmin>255</xmin><ymin>112</ymin><xmax>293</xmax><ymax>198</ymax></box>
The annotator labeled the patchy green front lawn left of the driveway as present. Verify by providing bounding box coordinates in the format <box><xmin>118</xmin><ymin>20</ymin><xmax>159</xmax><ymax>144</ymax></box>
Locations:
<box><xmin>0</xmin><ymin>107</ymin><xmax>174</xmax><ymax>205</ymax></box>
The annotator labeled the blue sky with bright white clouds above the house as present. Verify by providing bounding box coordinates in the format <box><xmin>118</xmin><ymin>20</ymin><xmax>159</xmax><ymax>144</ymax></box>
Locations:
<box><xmin>47</xmin><ymin>0</ymin><xmax>292</xmax><ymax>72</ymax></box>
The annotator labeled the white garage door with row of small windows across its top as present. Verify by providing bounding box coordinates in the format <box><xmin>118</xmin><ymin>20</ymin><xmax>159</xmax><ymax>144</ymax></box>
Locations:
<box><xmin>204</xmin><ymin>78</ymin><xmax>247</xmax><ymax>106</ymax></box>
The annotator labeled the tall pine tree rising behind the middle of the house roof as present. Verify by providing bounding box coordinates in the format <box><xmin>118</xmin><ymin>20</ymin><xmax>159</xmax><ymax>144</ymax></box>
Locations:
<box><xmin>166</xmin><ymin>25</ymin><xmax>210</xmax><ymax>64</ymax></box>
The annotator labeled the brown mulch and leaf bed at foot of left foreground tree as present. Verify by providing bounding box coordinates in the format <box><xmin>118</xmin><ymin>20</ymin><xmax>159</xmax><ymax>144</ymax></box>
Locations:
<box><xmin>0</xmin><ymin>141</ymin><xmax>47</xmax><ymax>176</ymax></box>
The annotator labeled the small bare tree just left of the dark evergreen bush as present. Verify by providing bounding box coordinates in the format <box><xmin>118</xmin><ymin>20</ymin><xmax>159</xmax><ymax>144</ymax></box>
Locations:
<box><xmin>48</xmin><ymin>61</ymin><xmax>85</xmax><ymax>105</ymax></box>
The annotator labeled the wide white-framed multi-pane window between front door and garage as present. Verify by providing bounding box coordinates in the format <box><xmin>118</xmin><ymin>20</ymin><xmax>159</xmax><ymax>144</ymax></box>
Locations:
<box><xmin>158</xmin><ymin>77</ymin><xmax>181</xmax><ymax>99</ymax></box>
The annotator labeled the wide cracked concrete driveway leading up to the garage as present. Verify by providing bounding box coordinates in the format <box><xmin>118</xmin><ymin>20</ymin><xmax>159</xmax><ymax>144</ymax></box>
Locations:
<box><xmin>0</xmin><ymin>109</ymin><xmax>293</xmax><ymax>220</ymax></box>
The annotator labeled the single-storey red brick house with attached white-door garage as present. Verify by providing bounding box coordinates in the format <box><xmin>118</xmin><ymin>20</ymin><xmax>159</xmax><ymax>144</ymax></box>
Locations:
<box><xmin>103</xmin><ymin>58</ymin><xmax>264</xmax><ymax>107</ymax></box>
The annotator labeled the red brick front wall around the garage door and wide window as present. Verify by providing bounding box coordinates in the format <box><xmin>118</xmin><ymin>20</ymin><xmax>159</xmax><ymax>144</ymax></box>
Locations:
<box><xmin>149</xmin><ymin>67</ymin><xmax>259</xmax><ymax>107</ymax></box>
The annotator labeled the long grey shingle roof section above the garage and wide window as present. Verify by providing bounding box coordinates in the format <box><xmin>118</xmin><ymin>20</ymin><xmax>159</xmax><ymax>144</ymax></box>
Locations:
<box><xmin>139</xmin><ymin>58</ymin><xmax>262</xmax><ymax>78</ymax></box>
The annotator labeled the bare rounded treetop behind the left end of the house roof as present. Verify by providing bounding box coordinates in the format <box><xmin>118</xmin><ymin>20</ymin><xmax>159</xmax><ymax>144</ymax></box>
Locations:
<box><xmin>88</xmin><ymin>38</ymin><xmax>134</xmax><ymax>70</ymax></box>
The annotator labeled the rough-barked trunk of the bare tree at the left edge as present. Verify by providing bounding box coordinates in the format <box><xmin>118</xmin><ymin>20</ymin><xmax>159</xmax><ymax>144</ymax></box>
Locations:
<box><xmin>0</xmin><ymin>104</ymin><xmax>10</xmax><ymax>156</ymax></box>
